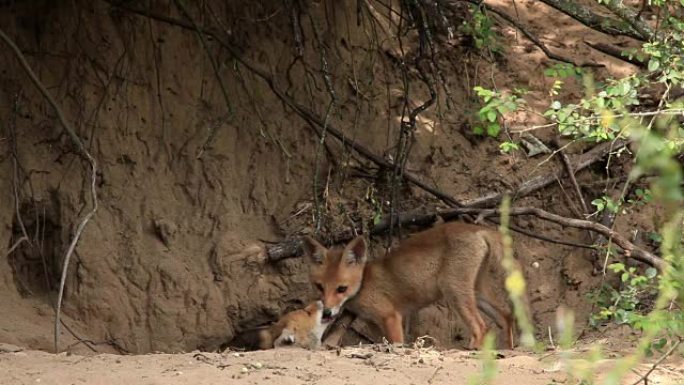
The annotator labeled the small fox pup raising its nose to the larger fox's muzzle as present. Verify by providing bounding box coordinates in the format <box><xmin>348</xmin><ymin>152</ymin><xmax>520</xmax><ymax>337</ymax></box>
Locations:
<box><xmin>228</xmin><ymin>301</ymin><xmax>329</xmax><ymax>350</ymax></box>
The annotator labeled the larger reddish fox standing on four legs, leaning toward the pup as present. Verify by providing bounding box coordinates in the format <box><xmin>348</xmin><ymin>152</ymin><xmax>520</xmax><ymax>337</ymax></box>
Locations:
<box><xmin>302</xmin><ymin>222</ymin><xmax>519</xmax><ymax>350</ymax></box>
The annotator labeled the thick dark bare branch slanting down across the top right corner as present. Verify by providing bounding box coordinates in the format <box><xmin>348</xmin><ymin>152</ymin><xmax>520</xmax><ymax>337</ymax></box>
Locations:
<box><xmin>541</xmin><ymin>0</ymin><xmax>648</xmax><ymax>41</ymax></box>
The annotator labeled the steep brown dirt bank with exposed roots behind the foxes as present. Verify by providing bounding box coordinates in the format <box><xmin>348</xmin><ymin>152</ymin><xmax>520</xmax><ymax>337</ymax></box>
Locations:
<box><xmin>0</xmin><ymin>0</ymin><xmax>664</xmax><ymax>354</ymax></box>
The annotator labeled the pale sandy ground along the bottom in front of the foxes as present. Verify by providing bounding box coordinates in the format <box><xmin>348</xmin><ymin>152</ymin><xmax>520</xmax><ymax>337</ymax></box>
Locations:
<box><xmin>0</xmin><ymin>346</ymin><xmax>684</xmax><ymax>385</ymax></box>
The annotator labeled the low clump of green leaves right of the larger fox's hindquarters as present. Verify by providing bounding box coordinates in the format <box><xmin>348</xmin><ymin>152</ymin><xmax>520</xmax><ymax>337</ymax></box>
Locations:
<box><xmin>589</xmin><ymin>263</ymin><xmax>658</xmax><ymax>327</ymax></box>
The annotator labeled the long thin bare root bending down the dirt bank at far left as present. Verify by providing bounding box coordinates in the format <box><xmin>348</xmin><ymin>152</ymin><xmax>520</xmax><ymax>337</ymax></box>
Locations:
<box><xmin>0</xmin><ymin>29</ymin><xmax>98</xmax><ymax>352</ymax></box>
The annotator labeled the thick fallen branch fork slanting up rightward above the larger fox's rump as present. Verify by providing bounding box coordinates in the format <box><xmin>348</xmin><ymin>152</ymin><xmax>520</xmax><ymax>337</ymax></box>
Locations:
<box><xmin>463</xmin><ymin>140</ymin><xmax>629</xmax><ymax>207</ymax></box>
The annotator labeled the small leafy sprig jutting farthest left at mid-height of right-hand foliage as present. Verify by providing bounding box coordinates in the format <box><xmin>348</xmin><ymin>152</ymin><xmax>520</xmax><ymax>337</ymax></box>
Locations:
<box><xmin>473</xmin><ymin>86</ymin><xmax>525</xmax><ymax>137</ymax></box>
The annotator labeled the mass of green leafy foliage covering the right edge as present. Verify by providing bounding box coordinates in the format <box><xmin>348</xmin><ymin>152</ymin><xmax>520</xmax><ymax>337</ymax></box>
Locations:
<box><xmin>475</xmin><ymin>0</ymin><xmax>684</xmax><ymax>385</ymax></box>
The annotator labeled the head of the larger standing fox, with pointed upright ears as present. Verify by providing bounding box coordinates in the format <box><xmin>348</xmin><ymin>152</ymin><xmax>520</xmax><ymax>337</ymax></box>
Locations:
<box><xmin>303</xmin><ymin>236</ymin><xmax>366</xmax><ymax>322</ymax></box>
